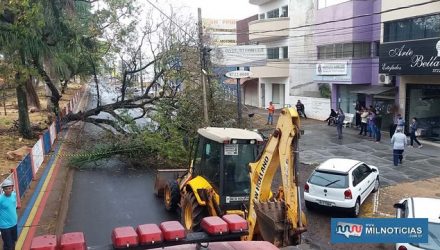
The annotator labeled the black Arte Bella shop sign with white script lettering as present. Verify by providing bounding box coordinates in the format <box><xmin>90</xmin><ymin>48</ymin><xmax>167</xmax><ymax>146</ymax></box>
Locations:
<box><xmin>379</xmin><ymin>38</ymin><xmax>440</xmax><ymax>75</ymax></box>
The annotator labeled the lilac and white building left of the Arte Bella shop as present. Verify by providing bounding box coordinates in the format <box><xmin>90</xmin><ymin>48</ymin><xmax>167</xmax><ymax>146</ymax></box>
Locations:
<box><xmin>314</xmin><ymin>0</ymin><xmax>388</xmax><ymax>124</ymax></box>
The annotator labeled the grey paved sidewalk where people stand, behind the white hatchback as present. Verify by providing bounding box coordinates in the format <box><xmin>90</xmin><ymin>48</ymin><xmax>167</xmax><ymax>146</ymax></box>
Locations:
<box><xmin>244</xmin><ymin>105</ymin><xmax>440</xmax><ymax>216</ymax></box>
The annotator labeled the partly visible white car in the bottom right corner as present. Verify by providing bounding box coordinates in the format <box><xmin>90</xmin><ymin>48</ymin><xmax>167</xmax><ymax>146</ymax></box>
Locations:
<box><xmin>394</xmin><ymin>197</ymin><xmax>440</xmax><ymax>250</ymax></box>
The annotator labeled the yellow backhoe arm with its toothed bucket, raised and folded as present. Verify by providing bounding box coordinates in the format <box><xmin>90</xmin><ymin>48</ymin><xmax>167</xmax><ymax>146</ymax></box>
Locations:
<box><xmin>247</xmin><ymin>108</ymin><xmax>305</xmax><ymax>246</ymax></box>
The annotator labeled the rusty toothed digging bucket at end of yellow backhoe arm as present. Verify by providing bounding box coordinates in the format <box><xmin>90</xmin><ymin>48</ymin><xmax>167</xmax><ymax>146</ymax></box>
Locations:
<box><xmin>254</xmin><ymin>201</ymin><xmax>300</xmax><ymax>247</ymax></box>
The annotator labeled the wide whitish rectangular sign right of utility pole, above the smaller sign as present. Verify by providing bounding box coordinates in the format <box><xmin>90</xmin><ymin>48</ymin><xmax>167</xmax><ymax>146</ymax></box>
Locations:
<box><xmin>211</xmin><ymin>45</ymin><xmax>267</xmax><ymax>67</ymax></box>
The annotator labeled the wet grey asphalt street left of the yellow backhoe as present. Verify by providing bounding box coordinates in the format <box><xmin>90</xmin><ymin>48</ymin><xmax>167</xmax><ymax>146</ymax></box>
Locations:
<box><xmin>63</xmin><ymin>84</ymin><xmax>177</xmax><ymax>246</ymax></box>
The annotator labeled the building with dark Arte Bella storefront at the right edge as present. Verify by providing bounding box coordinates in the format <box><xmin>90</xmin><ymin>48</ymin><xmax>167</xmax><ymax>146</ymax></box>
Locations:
<box><xmin>379</xmin><ymin>0</ymin><xmax>440</xmax><ymax>141</ymax></box>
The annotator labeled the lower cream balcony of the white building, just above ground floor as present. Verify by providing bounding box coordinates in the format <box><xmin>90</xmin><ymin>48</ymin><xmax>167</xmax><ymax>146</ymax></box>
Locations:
<box><xmin>250</xmin><ymin>59</ymin><xmax>289</xmax><ymax>78</ymax></box>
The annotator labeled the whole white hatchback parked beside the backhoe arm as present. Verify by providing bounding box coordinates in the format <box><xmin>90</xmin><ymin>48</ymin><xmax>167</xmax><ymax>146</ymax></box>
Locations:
<box><xmin>304</xmin><ymin>159</ymin><xmax>379</xmax><ymax>217</ymax></box>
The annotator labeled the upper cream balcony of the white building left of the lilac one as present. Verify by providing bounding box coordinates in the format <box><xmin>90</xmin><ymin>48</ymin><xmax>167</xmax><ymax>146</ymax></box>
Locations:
<box><xmin>249</xmin><ymin>17</ymin><xmax>290</xmax><ymax>42</ymax></box>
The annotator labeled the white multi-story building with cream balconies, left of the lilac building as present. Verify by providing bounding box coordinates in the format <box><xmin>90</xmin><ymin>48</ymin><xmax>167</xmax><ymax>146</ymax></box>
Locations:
<box><xmin>249</xmin><ymin>0</ymin><xmax>290</xmax><ymax>108</ymax></box>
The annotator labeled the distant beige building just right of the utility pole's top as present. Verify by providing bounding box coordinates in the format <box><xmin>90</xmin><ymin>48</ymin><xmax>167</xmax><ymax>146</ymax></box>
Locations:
<box><xmin>202</xmin><ymin>18</ymin><xmax>237</xmax><ymax>46</ymax></box>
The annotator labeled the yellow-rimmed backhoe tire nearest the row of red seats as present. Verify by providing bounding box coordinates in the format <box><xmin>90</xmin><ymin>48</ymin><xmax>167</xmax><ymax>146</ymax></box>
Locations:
<box><xmin>180</xmin><ymin>192</ymin><xmax>209</xmax><ymax>232</ymax></box>
